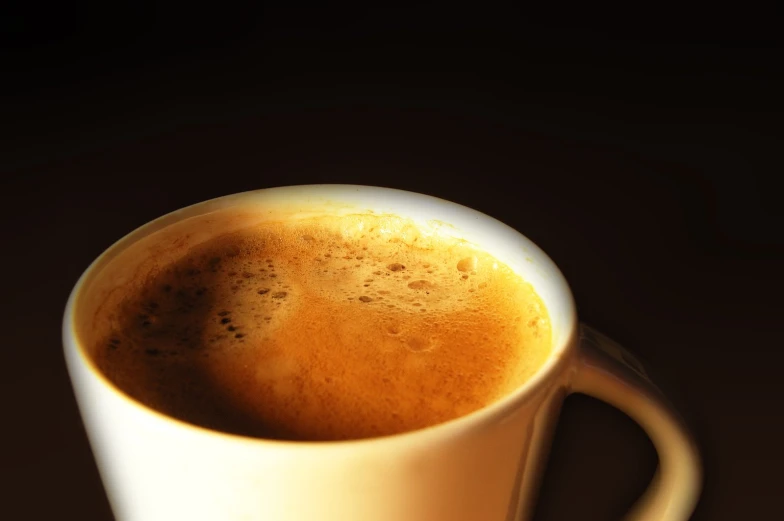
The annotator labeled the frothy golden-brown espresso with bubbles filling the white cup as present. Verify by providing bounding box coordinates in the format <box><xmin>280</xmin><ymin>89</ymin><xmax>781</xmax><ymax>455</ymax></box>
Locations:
<box><xmin>91</xmin><ymin>212</ymin><xmax>551</xmax><ymax>440</ymax></box>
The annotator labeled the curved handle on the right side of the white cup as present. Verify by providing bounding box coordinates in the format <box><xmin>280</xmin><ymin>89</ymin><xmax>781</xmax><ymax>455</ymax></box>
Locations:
<box><xmin>571</xmin><ymin>324</ymin><xmax>702</xmax><ymax>521</ymax></box>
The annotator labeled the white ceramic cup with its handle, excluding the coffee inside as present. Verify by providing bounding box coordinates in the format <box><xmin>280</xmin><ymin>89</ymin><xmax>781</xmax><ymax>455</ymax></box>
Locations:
<box><xmin>63</xmin><ymin>185</ymin><xmax>702</xmax><ymax>521</ymax></box>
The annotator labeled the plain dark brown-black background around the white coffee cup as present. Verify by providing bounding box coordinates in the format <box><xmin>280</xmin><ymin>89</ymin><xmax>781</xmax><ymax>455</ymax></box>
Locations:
<box><xmin>0</xmin><ymin>4</ymin><xmax>784</xmax><ymax>521</ymax></box>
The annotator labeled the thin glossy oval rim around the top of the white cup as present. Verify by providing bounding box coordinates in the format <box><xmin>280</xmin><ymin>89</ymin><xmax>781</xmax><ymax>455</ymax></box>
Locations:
<box><xmin>62</xmin><ymin>184</ymin><xmax>578</xmax><ymax>450</ymax></box>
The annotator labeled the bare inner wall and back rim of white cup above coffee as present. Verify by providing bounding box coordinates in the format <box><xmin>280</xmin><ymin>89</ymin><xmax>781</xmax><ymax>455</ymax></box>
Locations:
<box><xmin>65</xmin><ymin>185</ymin><xmax>577</xmax><ymax>440</ymax></box>
